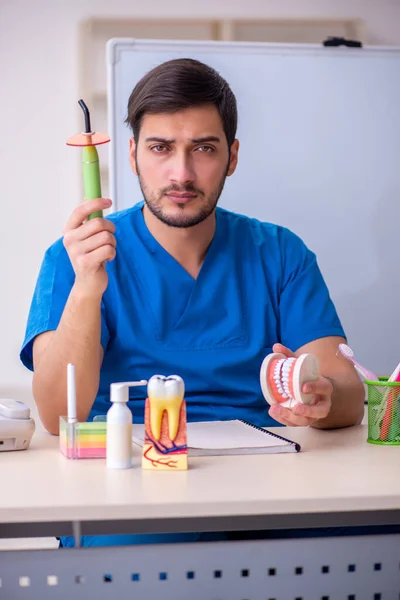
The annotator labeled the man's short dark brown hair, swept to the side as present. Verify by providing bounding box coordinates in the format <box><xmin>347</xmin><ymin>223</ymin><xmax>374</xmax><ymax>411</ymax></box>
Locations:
<box><xmin>125</xmin><ymin>58</ymin><xmax>237</xmax><ymax>147</ymax></box>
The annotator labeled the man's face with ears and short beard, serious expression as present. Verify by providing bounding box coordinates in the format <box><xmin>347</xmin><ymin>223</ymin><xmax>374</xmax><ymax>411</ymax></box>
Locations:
<box><xmin>129</xmin><ymin>105</ymin><xmax>239</xmax><ymax>227</ymax></box>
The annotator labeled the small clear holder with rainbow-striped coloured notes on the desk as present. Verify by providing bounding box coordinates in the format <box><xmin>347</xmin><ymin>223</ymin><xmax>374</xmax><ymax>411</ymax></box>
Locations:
<box><xmin>60</xmin><ymin>417</ymin><xmax>107</xmax><ymax>458</ymax></box>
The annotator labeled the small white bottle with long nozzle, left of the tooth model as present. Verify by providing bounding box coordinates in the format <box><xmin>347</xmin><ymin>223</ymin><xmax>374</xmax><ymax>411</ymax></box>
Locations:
<box><xmin>106</xmin><ymin>379</ymin><xmax>147</xmax><ymax>469</ymax></box>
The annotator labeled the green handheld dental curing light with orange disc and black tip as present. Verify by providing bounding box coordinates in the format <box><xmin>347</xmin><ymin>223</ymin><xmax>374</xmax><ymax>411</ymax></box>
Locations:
<box><xmin>67</xmin><ymin>100</ymin><xmax>110</xmax><ymax>219</ymax></box>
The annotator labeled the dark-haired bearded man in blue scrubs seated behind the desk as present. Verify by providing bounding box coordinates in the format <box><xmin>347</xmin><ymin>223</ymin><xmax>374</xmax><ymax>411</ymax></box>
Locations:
<box><xmin>21</xmin><ymin>59</ymin><xmax>364</xmax><ymax>546</ymax></box>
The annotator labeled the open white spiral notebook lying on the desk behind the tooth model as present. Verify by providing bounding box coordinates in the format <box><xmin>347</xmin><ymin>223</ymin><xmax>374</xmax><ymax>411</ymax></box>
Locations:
<box><xmin>132</xmin><ymin>421</ymin><xmax>300</xmax><ymax>456</ymax></box>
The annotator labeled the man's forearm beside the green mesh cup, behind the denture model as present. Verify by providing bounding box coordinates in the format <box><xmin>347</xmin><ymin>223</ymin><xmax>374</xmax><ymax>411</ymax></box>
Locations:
<box><xmin>311</xmin><ymin>373</ymin><xmax>365</xmax><ymax>429</ymax></box>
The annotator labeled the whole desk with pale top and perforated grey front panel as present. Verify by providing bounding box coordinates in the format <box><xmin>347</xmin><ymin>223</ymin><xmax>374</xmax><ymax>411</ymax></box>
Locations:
<box><xmin>0</xmin><ymin>425</ymin><xmax>400</xmax><ymax>600</ymax></box>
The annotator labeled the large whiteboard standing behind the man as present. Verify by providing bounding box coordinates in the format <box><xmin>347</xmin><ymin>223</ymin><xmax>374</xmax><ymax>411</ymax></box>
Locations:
<box><xmin>107</xmin><ymin>39</ymin><xmax>400</xmax><ymax>374</ymax></box>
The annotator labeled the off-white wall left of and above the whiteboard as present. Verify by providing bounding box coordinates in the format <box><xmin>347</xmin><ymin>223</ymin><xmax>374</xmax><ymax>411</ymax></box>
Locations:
<box><xmin>0</xmin><ymin>0</ymin><xmax>400</xmax><ymax>394</ymax></box>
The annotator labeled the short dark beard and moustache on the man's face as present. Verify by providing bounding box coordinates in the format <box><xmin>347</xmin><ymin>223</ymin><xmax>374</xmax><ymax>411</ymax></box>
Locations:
<box><xmin>136</xmin><ymin>161</ymin><xmax>229</xmax><ymax>229</ymax></box>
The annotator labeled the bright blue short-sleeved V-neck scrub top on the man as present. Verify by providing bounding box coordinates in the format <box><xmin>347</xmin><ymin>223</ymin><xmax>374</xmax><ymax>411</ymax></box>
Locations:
<box><xmin>20</xmin><ymin>202</ymin><xmax>344</xmax><ymax>426</ymax></box>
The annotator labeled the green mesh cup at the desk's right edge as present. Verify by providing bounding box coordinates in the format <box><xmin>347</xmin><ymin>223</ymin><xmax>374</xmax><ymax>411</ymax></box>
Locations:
<box><xmin>364</xmin><ymin>377</ymin><xmax>400</xmax><ymax>446</ymax></box>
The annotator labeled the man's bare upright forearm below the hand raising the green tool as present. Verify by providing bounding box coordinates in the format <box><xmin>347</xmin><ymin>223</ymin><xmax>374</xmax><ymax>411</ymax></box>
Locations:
<box><xmin>33</xmin><ymin>288</ymin><xmax>103</xmax><ymax>434</ymax></box>
